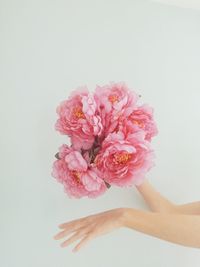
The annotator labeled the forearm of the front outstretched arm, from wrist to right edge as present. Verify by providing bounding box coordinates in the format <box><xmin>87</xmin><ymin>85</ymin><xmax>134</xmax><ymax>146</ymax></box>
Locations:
<box><xmin>123</xmin><ymin>208</ymin><xmax>200</xmax><ymax>248</ymax></box>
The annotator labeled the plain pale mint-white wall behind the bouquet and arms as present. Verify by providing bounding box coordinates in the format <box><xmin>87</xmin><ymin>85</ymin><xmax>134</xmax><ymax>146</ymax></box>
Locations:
<box><xmin>0</xmin><ymin>0</ymin><xmax>200</xmax><ymax>267</ymax></box>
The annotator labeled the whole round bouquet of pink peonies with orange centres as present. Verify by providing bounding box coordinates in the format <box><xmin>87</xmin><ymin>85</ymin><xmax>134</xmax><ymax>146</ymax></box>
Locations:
<box><xmin>51</xmin><ymin>82</ymin><xmax>158</xmax><ymax>198</ymax></box>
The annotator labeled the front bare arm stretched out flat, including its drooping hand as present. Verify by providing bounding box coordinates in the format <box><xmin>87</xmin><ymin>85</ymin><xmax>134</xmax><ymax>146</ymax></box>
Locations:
<box><xmin>54</xmin><ymin>208</ymin><xmax>200</xmax><ymax>252</ymax></box>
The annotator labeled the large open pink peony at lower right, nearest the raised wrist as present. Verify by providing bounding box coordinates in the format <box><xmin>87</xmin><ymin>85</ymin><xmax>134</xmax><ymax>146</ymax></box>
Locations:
<box><xmin>95</xmin><ymin>131</ymin><xmax>155</xmax><ymax>186</ymax></box>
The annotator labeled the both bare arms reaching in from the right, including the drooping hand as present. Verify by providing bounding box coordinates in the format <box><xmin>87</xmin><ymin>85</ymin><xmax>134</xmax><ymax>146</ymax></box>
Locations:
<box><xmin>54</xmin><ymin>180</ymin><xmax>200</xmax><ymax>252</ymax></box>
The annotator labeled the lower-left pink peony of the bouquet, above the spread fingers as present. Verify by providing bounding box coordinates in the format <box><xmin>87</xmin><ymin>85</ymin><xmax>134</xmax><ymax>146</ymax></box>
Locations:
<box><xmin>51</xmin><ymin>145</ymin><xmax>107</xmax><ymax>198</ymax></box>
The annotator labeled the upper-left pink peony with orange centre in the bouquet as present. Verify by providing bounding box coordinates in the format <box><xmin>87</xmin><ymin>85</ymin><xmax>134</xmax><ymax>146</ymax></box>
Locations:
<box><xmin>55</xmin><ymin>87</ymin><xmax>102</xmax><ymax>149</ymax></box>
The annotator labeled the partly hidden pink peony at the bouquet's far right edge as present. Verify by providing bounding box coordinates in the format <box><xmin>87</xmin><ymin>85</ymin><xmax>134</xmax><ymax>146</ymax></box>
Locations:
<box><xmin>126</xmin><ymin>104</ymin><xmax>158</xmax><ymax>141</ymax></box>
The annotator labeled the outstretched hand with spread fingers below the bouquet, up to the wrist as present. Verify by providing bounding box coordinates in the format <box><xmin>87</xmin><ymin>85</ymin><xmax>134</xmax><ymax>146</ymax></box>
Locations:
<box><xmin>54</xmin><ymin>208</ymin><xmax>125</xmax><ymax>252</ymax></box>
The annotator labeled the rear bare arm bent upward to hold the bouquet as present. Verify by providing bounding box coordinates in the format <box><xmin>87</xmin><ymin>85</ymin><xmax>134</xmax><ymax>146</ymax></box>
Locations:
<box><xmin>136</xmin><ymin>180</ymin><xmax>200</xmax><ymax>215</ymax></box>
